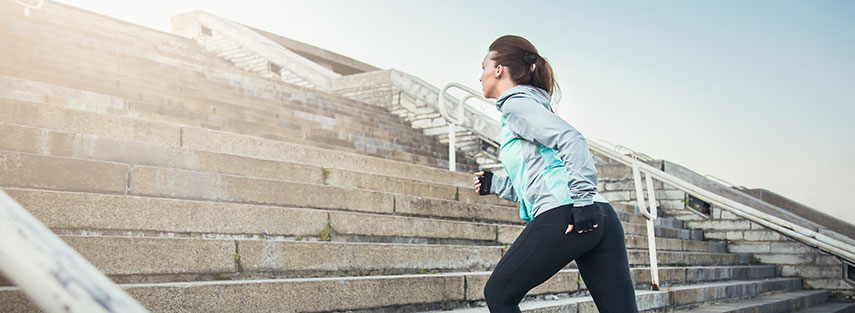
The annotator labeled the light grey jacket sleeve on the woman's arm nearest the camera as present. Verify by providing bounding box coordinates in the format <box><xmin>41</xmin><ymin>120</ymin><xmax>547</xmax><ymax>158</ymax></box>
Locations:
<box><xmin>502</xmin><ymin>94</ymin><xmax>597</xmax><ymax>207</ymax></box>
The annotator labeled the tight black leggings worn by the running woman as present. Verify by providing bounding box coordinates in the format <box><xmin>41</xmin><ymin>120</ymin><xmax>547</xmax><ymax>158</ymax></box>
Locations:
<box><xmin>484</xmin><ymin>202</ymin><xmax>638</xmax><ymax>313</ymax></box>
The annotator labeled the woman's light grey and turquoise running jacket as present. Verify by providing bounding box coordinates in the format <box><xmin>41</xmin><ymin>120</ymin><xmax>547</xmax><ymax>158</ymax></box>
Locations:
<box><xmin>490</xmin><ymin>85</ymin><xmax>608</xmax><ymax>223</ymax></box>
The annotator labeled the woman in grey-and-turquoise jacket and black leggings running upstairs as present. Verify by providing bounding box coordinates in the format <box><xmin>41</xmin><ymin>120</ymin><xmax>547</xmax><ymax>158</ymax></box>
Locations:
<box><xmin>474</xmin><ymin>36</ymin><xmax>638</xmax><ymax>313</ymax></box>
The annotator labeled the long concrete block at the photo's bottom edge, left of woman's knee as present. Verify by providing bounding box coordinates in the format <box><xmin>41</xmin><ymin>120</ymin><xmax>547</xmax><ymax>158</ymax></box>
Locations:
<box><xmin>126</xmin><ymin>274</ymin><xmax>464</xmax><ymax>312</ymax></box>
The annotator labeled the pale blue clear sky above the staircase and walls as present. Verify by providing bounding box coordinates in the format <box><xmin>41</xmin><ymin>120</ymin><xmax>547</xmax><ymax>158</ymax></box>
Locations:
<box><xmin>55</xmin><ymin>0</ymin><xmax>855</xmax><ymax>223</ymax></box>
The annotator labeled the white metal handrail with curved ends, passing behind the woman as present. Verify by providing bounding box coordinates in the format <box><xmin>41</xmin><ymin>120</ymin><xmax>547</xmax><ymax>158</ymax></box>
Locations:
<box><xmin>438</xmin><ymin>83</ymin><xmax>855</xmax><ymax>290</ymax></box>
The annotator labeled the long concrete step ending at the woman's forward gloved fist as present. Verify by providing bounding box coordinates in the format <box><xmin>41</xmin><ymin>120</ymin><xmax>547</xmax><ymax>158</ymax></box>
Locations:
<box><xmin>0</xmin><ymin>95</ymin><xmax>482</xmax><ymax>188</ymax></box>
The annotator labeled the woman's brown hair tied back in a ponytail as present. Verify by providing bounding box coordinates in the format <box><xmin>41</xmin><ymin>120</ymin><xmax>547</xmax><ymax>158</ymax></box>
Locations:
<box><xmin>488</xmin><ymin>35</ymin><xmax>561</xmax><ymax>112</ymax></box>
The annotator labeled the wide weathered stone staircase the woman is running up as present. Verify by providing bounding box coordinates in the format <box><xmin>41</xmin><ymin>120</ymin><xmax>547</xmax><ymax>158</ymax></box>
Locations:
<box><xmin>0</xmin><ymin>2</ymin><xmax>855</xmax><ymax>312</ymax></box>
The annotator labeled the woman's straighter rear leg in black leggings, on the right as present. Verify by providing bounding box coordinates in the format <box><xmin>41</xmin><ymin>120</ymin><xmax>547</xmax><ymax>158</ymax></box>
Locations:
<box><xmin>576</xmin><ymin>203</ymin><xmax>638</xmax><ymax>313</ymax></box>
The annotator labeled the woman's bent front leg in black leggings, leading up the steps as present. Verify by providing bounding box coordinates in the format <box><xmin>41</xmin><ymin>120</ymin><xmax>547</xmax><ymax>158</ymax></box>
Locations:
<box><xmin>484</xmin><ymin>205</ymin><xmax>604</xmax><ymax>313</ymax></box>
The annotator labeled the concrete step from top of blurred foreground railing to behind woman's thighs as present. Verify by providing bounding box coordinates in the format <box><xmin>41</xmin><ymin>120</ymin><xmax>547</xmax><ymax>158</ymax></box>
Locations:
<box><xmin>5</xmin><ymin>188</ymin><xmax>726</xmax><ymax>246</ymax></box>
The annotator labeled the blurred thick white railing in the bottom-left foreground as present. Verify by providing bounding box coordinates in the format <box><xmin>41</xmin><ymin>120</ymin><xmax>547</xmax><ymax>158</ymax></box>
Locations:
<box><xmin>0</xmin><ymin>190</ymin><xmax>148</xmax><ymax>313</ymax></box>
